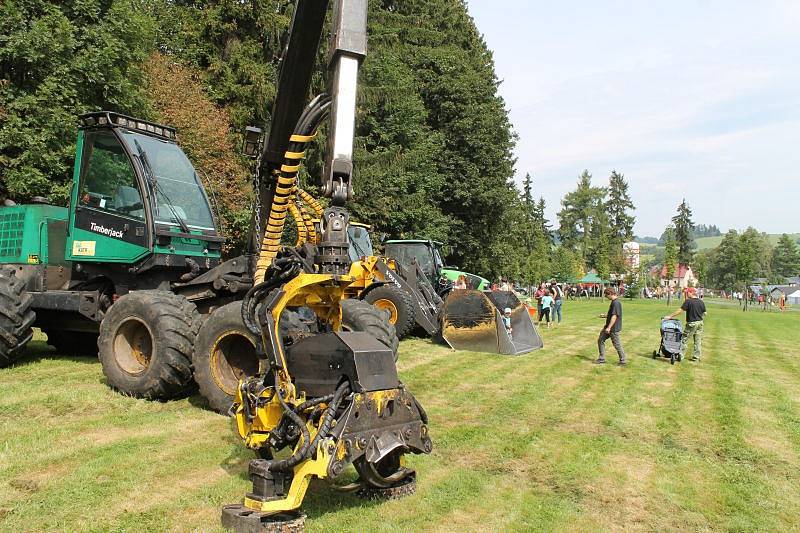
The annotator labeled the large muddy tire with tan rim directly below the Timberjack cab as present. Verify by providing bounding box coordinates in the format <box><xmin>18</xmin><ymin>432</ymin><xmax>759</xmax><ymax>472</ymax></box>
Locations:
<box><xmin>97</xmin><ymin>290</ymin><xmax>200</xmax><ymax>400</ymax></box>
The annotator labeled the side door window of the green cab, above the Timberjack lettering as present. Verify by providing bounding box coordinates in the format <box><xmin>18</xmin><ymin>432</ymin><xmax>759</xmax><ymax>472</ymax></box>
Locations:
<box><xmin>78</xmin><ymin>132</ymin><xmax>144</xmax><ymax>220</ymax></box>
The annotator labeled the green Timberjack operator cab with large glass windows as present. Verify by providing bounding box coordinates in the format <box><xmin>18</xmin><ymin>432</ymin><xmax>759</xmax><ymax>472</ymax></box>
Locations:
<box><xmin>66</xmin><ymin>111</ymin><xmax>222</xmax><ymax>266</ymax></box>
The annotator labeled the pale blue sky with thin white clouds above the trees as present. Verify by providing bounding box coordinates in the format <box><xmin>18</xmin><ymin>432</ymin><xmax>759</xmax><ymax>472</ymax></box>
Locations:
<box><xmin>467</xmin><ymin>0</ymin><xmax>800</xmax><ymax>236</ymax></box>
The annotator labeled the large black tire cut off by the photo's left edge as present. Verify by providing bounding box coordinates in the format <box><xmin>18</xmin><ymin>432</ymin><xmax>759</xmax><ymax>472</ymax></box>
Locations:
<box><xmin>0</xmin><ymin>268</ymin><xmax>36</xmax><ymax>368</ymax></box>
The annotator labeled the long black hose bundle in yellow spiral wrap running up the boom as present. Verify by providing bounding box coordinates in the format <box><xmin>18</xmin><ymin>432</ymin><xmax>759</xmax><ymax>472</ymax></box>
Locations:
<box><xmin>254</xmin><ymin>94</ymin><xmax>331</xmax><ymax>283</ymax></box>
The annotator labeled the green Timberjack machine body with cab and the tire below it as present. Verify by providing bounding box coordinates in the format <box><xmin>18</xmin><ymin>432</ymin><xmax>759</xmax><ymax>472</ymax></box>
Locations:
<box><xmin>0</xmin><ymin>112</ymin><xmax>252</xmax><ymax>399</ymax></box>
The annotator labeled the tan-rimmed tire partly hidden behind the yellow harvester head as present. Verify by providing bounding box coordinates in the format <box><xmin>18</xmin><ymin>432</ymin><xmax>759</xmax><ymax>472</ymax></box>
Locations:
<box><xmin>192</xmin><ymin>302</ymin><xmax>309</xmax><ymax>415</ymax></box>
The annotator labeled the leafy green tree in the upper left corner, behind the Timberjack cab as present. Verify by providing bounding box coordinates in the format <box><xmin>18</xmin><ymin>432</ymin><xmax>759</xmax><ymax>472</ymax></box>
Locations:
<box><xmin>0</xmin><ymin>0</ymin><xmax>153</xmax><ymax>203</ymax></box>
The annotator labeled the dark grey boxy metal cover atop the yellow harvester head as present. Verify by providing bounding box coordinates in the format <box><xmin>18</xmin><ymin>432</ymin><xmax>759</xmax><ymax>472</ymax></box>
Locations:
<box><xmin>286</xmin><ymin>331</ymin><xmax>400</xmax><ymax>398</ymax></box>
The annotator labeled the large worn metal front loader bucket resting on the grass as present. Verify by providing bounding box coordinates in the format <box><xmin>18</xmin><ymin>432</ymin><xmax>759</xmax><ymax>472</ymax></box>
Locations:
<box><xmin>442</xmin><ymin>289</ymin><xmax>544</xmax><ymax>355</ymax></box>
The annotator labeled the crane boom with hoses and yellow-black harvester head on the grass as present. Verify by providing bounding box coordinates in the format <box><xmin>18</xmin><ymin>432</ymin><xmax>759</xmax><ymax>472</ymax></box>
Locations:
<box><xmin>207</xmin><ymin>0</ymin><xmax>432</xmax><ymax>531</ymax></box>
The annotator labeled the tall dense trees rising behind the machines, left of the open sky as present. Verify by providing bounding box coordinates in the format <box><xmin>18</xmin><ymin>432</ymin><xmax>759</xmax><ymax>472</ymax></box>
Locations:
<box><xmin>0</xmin><ymin>0</ymin><xmax>525</xmax><ymax>276</ymax></box>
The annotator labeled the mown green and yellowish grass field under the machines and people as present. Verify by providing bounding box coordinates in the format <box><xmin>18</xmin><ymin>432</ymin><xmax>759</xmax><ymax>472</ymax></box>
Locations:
<box><xmin>0</xmin><ymin>301</ymin><xmax>800</xmax><ymax>532</ymax></box>
